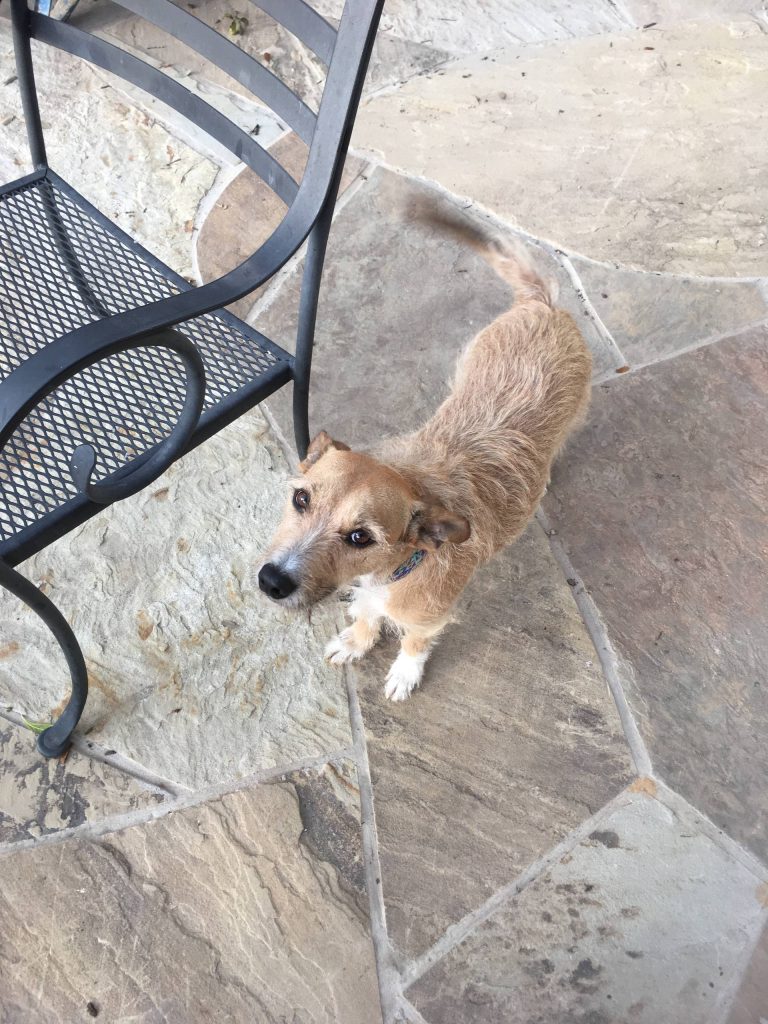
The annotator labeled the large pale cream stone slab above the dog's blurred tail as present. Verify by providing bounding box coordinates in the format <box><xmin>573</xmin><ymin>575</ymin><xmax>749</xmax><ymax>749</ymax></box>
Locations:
<box><xmin>353</xmin><ymin>18</ymin><xmax>768</xmax><ymax>276</ymax></box>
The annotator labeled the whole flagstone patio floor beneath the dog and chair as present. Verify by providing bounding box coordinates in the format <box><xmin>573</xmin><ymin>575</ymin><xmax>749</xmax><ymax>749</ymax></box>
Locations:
<box><xmin>0</xmin><ymin>0</ymin><xmax>768</xmax><ymax>1024</ymax></box>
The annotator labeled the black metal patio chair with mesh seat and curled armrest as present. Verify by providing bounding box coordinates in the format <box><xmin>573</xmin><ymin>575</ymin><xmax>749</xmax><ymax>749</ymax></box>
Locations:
<box><xmin>0</xmin><ymin>0</ymin><xmax>383</xmax><ymax>757</ymax></box>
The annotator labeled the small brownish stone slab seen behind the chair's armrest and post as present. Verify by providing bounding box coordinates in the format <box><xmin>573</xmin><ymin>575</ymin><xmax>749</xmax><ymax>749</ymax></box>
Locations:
<box><xmin>196</xmin><ymin>132</ymin><xmax>365</xmax><ymax>318</ymax></box>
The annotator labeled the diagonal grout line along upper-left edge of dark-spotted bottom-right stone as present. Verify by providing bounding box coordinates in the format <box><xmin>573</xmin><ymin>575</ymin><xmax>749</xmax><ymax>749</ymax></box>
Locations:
<box><xmin>402</xmin><ymin>790</ymin><xmax>633</xmax><ymax>990</ymax></box>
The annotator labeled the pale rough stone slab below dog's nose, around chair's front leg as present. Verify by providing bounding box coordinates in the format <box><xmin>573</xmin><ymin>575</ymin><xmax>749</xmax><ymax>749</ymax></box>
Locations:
<box><xmin>0</xmin><ymin>412</ymin><xmax>350</xmax><ymax>788</ymax></box>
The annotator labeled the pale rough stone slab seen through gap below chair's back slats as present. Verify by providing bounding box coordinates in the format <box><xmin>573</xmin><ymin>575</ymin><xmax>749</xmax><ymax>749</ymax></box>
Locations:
<box><xmin>0</xmin><ymin>28</ymin><xmax>218</xmax><ymax>278</ymax></box>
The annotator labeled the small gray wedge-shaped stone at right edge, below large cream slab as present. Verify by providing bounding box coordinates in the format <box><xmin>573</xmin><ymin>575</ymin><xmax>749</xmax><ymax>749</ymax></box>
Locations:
<box><xmin>573</xmin><ymin>257</ymin><xmax>768</xmax><ymax>366</ymax></box>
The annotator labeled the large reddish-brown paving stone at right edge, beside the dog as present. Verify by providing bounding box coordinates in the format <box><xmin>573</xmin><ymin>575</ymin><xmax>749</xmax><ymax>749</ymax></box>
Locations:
<box><xmin>545</xmin><ymin>328</ymin><xmax>768</xmax><ymax>857</ymax></box>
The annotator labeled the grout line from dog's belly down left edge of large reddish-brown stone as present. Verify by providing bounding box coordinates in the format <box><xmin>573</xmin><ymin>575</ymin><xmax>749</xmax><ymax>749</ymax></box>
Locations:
<box><xmin>536</xmin><ymin>507</ymin><xmax>651</xmax><ymax>775</ymax></box>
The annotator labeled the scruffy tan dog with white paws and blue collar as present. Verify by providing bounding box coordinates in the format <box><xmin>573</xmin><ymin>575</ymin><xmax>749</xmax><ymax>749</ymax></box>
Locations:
<box><xmin>259</xmin><ymin>213</ymin><xmax>592</xmax><ymax>700</ymax></box>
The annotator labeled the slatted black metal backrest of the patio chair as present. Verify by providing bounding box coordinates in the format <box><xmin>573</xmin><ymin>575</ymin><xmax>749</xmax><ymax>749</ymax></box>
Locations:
<box><xmin>11</xmin><ymin>0</ymin><xmax>383</xmax><ymax>226</ymax></box>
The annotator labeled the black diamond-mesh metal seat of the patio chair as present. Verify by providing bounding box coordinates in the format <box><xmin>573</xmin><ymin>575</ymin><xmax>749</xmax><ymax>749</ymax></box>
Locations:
<box><xmin>0</xmin><ymin>171</ymin><xmax>292</xmax><ymax>557</ymax></box>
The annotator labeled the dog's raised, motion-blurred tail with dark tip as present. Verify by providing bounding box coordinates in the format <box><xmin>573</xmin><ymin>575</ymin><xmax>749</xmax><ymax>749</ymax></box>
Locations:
<box><xmin>408</xmin><ymin>197</ymin><xmax>558</xmax><ymax>307</ymax></box>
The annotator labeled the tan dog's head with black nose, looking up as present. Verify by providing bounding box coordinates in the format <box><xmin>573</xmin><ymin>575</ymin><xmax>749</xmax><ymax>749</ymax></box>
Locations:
<box><xmin>259</xmin><ymin>431</ymin><xmax>470</xmax><ymax>607</ymax></box>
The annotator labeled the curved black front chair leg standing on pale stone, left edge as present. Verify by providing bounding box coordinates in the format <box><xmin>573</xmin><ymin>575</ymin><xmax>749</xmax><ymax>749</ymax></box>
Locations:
<box><xmin>0</xmin><ymin>561</ymin><xmax>88</xmax><ymax>758</ymax></box>
